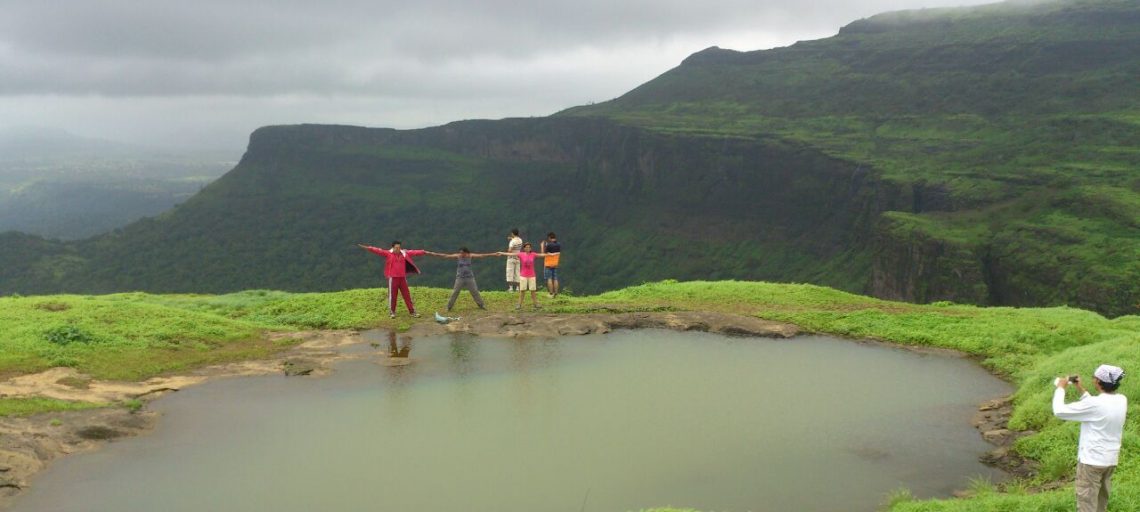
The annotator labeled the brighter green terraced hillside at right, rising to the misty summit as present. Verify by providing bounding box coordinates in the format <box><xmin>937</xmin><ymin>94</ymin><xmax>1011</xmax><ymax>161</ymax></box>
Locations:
<box><xmin>562</xmin><ymin>0</ymin><xmax>1140</xmax><ymax>314</ymax></box>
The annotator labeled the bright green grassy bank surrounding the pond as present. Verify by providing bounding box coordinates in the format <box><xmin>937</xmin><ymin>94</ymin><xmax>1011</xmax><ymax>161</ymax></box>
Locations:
<box><xmin>0</xmin><ymin>282</ymin><xmax>1140</xmax><ymax>512</ymax></box>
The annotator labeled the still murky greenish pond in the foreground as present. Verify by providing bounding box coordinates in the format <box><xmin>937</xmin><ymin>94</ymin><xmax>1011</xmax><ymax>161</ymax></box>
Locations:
<box><xmin>15</xmin><ymin>331</ymin><xmax>1009</xmax><ymax>512</ymax></box>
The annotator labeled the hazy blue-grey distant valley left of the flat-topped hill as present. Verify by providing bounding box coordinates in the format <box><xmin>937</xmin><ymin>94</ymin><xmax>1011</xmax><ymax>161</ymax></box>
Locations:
<box><xmin>0</xmin><ymin>129</ymin><xmax>237</xmax><ymax>239</ymax></box>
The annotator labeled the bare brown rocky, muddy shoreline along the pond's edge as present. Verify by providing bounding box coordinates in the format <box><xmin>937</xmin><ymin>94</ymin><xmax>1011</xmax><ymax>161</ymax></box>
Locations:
<box><xmin>0</xmin><ymin>312</ymin><xmax>1035</xmax><ymax>511</ymax></box>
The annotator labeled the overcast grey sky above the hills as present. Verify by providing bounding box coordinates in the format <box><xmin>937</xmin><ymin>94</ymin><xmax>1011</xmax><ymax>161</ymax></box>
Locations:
<box><xmin>0</xmin><ymin>0</ymin><xmax>992</xmax><ymax>149</ymax></box>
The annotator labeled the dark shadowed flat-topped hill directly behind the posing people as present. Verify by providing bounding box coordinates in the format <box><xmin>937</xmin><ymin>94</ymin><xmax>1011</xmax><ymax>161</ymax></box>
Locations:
<box><xmin>0</xmin><ymin>120</ymin><xmax>866</xmax><ymax>293</ymax></box>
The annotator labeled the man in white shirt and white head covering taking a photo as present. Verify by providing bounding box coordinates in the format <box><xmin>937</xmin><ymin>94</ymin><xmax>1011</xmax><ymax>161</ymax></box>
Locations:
<box><xmin>1053</xmin><ymin>365</ymin><xmax>1129</xmax><ymax>512</ymax></box>
